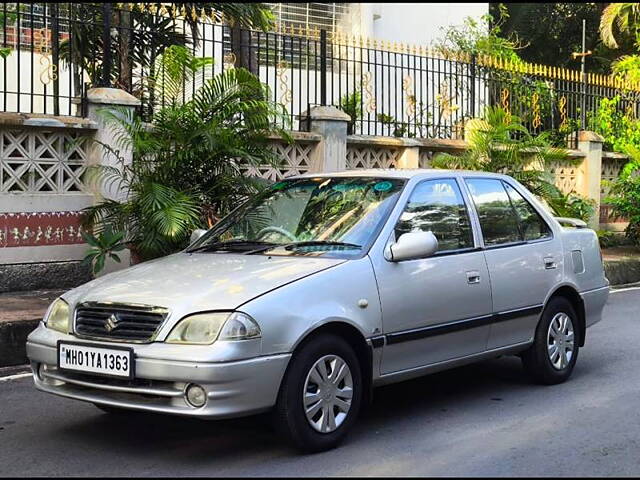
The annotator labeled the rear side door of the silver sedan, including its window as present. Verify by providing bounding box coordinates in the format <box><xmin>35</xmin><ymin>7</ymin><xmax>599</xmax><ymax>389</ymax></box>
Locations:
<box><xmin>465</xmin><ymin>178</ymin><xmax>562</xmax><ymax>349</ymax></box>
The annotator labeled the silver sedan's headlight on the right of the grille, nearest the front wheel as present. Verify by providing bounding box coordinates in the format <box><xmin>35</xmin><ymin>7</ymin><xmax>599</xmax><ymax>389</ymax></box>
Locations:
<box><xmin>165</xmin><ymin>312</ymin><xmax>260</xmax><ymax>345</ymax></box>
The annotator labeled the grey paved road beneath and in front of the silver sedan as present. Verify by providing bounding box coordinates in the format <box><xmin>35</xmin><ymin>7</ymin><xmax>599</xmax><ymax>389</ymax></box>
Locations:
<box><xmin>0</xmin><ymin>290</ymin><xmax>640</xmax><ymax>476</ymax></box>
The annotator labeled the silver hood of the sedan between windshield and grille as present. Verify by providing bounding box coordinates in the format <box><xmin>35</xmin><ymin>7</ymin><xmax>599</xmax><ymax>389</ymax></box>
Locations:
<box><xmin>63</xmin><ymin>252</ymin><xmax>345</xmax><ymax>314</ymax></box>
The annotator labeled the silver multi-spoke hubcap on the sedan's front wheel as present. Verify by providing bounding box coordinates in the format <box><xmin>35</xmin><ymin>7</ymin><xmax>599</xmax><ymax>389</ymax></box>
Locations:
<box><xmin>302</xmin><ymin>355</ymin><xmax>353</xmax><ymax>433</ymax></box>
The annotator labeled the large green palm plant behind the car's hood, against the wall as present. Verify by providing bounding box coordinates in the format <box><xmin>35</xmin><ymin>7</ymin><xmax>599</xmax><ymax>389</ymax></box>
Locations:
<box><xmin>83</xmin><ymin>47</ymin><xmax>289</xmax><ymax>260</ymax></box>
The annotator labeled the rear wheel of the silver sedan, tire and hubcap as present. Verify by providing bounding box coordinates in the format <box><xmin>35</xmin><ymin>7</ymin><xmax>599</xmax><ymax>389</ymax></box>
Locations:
<box><xmin>521</xmin><ymin>297</ymin><xmax>582</xmax><ymax>385</ymax></box>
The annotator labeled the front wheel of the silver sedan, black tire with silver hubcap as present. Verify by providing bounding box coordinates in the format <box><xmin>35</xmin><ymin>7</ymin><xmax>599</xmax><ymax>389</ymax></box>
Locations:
<box><xmin>274</xmin><ymin>334</ymin><xmax>363</xmax><ymax>453</ymax></box>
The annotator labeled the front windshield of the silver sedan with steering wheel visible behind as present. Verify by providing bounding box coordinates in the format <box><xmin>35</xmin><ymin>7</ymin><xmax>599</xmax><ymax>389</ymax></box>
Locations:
<box><xmin>187</xmin><ymin>177</ymin><xmax>405</xmax><ymax>257</ymax></box>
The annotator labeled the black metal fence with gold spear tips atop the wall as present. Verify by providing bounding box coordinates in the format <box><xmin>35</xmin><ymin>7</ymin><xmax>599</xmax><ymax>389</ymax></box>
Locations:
<box><xmin>0</xmin><ymin>3</ymin><xmax>640</xmax><ymax>144</ymax></box>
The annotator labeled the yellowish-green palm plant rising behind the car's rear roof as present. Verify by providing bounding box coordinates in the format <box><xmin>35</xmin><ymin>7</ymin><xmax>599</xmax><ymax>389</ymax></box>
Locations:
<box><xmin>432</xmin><ymin>106</ymin><xmax>570</xmax><ymax>203</ymax></box>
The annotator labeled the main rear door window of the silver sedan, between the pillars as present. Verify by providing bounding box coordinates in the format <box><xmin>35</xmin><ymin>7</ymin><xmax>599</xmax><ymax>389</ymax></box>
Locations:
<box><xmin>465</xmin><ymin>178</ymin><xmax>522</xmax><ymax>246</ymax></box>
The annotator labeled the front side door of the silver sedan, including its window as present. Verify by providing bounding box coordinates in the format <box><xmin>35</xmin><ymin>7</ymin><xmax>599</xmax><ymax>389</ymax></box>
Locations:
<box><xmin>372</xmin><ymin>178</ymin><xmax>491</xmax><ymax>374</ymax></box>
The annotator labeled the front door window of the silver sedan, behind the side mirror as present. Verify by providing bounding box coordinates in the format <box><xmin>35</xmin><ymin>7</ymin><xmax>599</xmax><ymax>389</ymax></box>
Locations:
<box><xmin>395</xmin><ymin>178</ymin><xmax>474</xmax><ymax>252</ymax></box>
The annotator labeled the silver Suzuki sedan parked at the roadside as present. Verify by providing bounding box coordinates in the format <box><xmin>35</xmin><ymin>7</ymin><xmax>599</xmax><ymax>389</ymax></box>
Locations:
<box><xmin>27</xmin><ymin>170</ymin><xmax>609</xmax><ymax>451</ymax></box>
